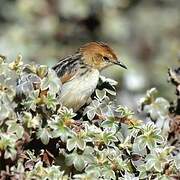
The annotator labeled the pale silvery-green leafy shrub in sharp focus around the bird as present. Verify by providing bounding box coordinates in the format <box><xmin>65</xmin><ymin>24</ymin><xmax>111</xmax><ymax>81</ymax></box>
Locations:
<box><xmin>0</xmin><ymin>56</ymin><xmax>180</xmax><ymax>180</ymax></box>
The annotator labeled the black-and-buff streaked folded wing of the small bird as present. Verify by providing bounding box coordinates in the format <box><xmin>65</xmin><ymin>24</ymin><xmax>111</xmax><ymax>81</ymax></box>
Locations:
<box><xmin>52</xmin><ymin>53</ymin><xmax>81</xmax><ymax>84</ymax></box>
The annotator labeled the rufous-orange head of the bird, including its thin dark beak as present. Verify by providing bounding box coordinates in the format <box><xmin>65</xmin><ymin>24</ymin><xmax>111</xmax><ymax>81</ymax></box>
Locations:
<box><xmin>80</xmin><ymin>42</ymin><xmax>127</xmax><ymax>70</ymax></box>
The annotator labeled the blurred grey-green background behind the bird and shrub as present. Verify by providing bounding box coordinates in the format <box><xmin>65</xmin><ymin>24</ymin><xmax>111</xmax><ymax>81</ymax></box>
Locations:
<box><xmin>0</xmin><ymin>0</ymin><xmax>180</xmax><ymax>108</ymax></box>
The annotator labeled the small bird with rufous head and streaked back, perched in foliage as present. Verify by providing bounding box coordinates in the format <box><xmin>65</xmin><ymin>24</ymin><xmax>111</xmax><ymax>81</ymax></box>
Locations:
<box><xmin>53</xmin><ymin>42</ymin><xmax>127</xmax><ymax>112</ymax></box>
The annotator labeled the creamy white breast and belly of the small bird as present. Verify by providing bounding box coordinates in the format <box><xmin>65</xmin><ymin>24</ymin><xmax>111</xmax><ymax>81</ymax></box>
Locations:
<box><xmin>61</xmin><ymin>69</ymin><xmax>99</xmax><ymax>111</ymax></box>
